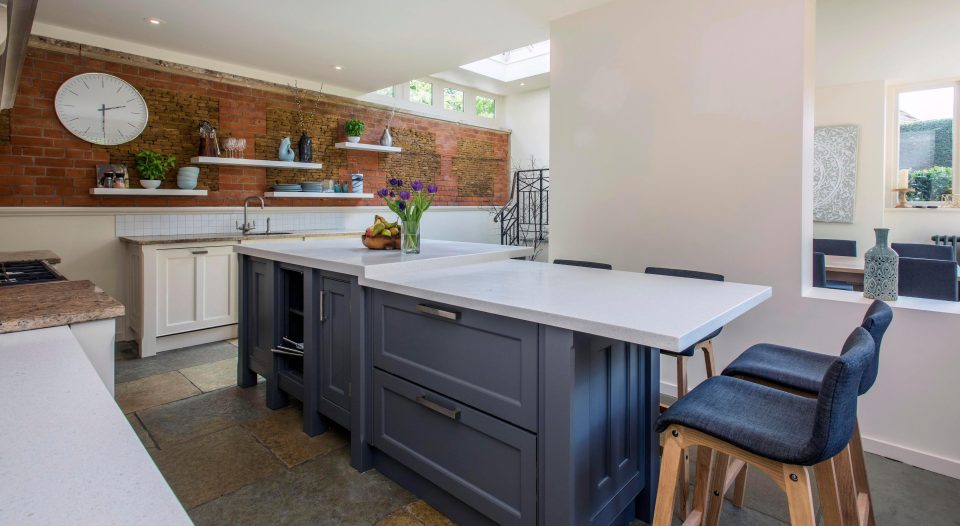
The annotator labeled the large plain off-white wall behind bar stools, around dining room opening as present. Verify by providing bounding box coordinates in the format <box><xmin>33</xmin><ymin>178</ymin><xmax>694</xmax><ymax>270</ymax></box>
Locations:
<box><xmin>550</xmin><ymin>0</ymin><xmax>960</xmax><ymax>477</ymax></box>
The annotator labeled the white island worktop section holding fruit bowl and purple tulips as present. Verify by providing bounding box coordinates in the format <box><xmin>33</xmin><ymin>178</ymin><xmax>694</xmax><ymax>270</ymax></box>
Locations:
<box><xmin>234</xmin><ymin>236</ymin><xmax>533</xmax><ymax>277</ymax></box>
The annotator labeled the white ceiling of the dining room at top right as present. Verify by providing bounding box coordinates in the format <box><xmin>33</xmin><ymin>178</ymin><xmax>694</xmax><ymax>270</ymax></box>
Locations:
<box><xmin>817</xmin><ymin>0</ymin><xmax>960</xmax><ymax>86</ymax></box>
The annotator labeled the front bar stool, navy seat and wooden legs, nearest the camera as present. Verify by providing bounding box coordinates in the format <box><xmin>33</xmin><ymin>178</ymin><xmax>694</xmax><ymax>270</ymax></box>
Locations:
<box><xmin>653</xmin><ymin>327</ymin><xmax>876</xmax><ymax>526</ymax></box>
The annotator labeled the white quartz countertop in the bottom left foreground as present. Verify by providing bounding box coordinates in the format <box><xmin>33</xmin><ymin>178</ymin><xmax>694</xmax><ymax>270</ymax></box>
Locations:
<box><xmin>0</xmin><ymin>327</ymin><xmax>192</xmax><ymax>525</ymax></box>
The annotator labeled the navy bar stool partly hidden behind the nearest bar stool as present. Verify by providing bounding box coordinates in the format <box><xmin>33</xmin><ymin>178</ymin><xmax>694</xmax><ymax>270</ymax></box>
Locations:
<box><xmin>722</xmin><ymin>300</ymin><xmax>893</xmax><ymax>526</ymax></box>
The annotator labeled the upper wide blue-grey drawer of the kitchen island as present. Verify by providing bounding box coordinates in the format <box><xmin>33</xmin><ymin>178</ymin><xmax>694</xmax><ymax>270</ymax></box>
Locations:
<box><xmin>373</xmin><ymin>291</ymin><xmax>539</xmax><ymax>432</ymax></box>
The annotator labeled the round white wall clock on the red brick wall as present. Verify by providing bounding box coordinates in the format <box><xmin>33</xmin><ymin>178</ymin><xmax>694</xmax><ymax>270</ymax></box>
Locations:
<box><xmin>54</xmin><ymin>73</ymin><xmax>147</xmax><ymax>145</ymax></box>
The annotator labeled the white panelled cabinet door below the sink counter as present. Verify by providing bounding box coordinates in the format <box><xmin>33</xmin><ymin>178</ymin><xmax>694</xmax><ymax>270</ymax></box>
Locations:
<box><xmin>157</xmin><ymin>246</ymin><xmax>237</xmax><ymax>336</ymax></box>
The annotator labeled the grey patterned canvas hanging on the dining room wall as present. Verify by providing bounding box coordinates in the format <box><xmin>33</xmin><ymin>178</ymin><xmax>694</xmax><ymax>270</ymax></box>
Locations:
<box><xmin>813</xmin><ymin>126</ymin><xmax>860</xmax><ymax>223</ymax></box>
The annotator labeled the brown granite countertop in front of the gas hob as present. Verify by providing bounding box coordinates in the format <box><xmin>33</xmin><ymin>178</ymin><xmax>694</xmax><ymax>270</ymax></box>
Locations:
<box><xmin>0</xmin><ymin>281</ymin><xmax>124</xmax><ymax>334</ymax></box>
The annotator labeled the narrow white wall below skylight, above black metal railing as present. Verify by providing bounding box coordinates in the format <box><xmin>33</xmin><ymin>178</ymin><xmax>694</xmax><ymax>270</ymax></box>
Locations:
<box><xmin>506</xmin><ymin>88</ymin><xmax>550</xmax><ymax>172</ymax></box>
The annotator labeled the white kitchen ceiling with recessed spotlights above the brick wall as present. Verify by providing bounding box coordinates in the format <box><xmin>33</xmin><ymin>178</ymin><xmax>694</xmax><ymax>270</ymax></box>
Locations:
<box><xmin>34</xmin><ymin>0</ymin><xmax>607</xmax><ymax>93</ymax></box>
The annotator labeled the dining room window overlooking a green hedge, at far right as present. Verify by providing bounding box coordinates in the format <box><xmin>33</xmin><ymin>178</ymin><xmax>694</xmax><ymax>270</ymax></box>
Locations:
<box><xmin>896</xmin><ymin>85</ymin><xmax>957</xmax><ymax>201</ymax></box>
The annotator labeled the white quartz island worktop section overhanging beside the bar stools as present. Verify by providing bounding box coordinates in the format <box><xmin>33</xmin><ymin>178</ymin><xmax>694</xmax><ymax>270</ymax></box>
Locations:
<box><xmin>360</xmin><ymin>260</ymin><xmax>772</xmax><ymax>351</ymax></box>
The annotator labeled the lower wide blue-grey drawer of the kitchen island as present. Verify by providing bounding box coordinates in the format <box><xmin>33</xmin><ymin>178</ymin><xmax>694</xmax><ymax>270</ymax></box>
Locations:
<box><xmin>372</xmin><ymin>370</ymin><xmax>537</xmax><ymax>524</ymax></box>
